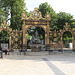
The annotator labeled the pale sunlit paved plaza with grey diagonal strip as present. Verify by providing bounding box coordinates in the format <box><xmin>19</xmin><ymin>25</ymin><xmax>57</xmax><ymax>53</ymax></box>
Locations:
<box><xmin>0</xmin><ymin>53</ymin><xmax>75</xmax><ymax>75</ymax></box>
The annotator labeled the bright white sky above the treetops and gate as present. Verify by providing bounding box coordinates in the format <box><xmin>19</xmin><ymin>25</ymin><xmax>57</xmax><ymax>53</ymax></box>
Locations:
<box><xmin>25</xmin><ymin>0</ymin><xmax>75</xmax><ymax>19</ymax></box>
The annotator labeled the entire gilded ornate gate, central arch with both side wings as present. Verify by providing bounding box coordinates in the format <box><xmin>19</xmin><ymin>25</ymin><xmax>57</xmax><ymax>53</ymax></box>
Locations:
<box><xmin>0</xmin><ymin>8</ymin><xmax>75</xmax><ymax>50</ymax></box>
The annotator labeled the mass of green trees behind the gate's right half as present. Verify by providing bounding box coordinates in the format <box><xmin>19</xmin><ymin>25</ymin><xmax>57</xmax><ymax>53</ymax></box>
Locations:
<box><xmin>39</xmin><ymin>2</ymin><xmax>75</xmax><ymax>31</ymax></box>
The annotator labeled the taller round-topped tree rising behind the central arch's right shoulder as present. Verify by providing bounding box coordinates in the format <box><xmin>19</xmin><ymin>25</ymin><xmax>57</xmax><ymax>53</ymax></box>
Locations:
<box><xmin>39</xmin><ymin>2</ymin><xmax>57</xmax><ymax>30</ymax></box>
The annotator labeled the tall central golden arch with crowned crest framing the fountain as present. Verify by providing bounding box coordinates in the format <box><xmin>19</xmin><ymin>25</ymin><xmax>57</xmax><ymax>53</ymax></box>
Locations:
<box><xmin>22</xmin><ymin>8</ymin><xmax>50</xmax><ymax>50</ymax></box>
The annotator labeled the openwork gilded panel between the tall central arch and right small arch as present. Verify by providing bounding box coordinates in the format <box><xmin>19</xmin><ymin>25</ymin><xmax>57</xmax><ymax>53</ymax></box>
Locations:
<box><xmin>50</xmin><ymin>30</ymin><xmax>63</xmax><ymax>50</ymax></box>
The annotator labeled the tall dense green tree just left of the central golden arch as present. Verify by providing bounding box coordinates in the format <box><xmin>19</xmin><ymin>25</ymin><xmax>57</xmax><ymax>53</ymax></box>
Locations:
<box><xmin>10</xmin><ymin>0</ymin><xmax>25</xmax><ymax>30</ymax></box>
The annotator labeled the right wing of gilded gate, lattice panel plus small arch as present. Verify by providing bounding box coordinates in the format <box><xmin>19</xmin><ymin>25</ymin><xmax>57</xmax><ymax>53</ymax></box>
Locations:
<box><xmin>49</xmin><ymin>22</ymin><xmax>75</xmax><ymax>50</ymax></box>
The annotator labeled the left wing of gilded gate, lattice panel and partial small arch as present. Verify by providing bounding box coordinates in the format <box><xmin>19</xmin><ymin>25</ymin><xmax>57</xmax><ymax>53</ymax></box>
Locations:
<box><xmin>0</xmin><ymin>21</ymin><xmax>23</xmax><ymax>50</ymax></box>
